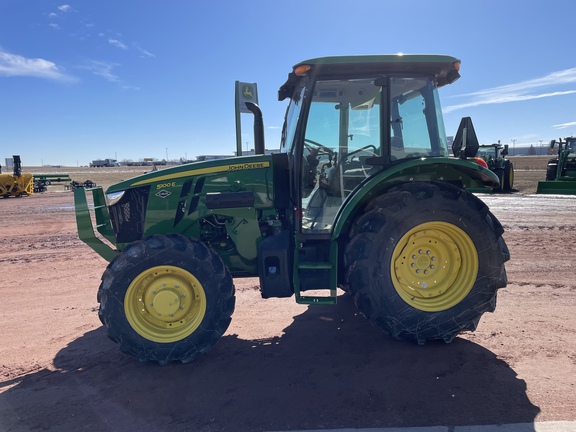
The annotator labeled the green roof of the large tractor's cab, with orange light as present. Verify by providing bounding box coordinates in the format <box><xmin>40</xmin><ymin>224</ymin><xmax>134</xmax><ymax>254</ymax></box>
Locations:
<box><xmin>278</xmin><ymin>54</ymin><xmax>460</xmax><ymax>100</ymax></box>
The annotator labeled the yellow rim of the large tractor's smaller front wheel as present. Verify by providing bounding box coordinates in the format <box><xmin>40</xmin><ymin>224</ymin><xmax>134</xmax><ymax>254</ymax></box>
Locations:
<box><xmin>124</xmin><ymin>266</ymin><xmax>206</xmax><ymax>343</ymax></box>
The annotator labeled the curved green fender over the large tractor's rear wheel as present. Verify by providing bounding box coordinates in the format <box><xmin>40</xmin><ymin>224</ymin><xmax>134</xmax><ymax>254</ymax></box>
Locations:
<box><xmin>332</xmin><ymin>157</ymin><xmax>499</xmax><ymax>240</ymax></box>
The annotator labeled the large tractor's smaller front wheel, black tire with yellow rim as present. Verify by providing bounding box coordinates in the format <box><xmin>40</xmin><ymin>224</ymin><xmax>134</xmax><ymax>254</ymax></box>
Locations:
<box><xmin>98</xmin><ymin>234</ymin><xmax>235</xmax><ymax>364</ymax></box>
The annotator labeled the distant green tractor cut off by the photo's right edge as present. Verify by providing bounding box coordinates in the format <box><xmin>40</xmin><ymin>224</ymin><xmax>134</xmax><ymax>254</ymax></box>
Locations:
<box><xmin>536</xmin><ymin>137</ymin><xmax>576</xmax><ymax>195</ymax></box>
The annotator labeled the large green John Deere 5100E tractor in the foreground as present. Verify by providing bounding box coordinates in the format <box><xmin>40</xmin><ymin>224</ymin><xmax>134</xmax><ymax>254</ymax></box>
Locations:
<box><xmin>74</xmin><ymin>55</ymin><xmax>509</xmax><ymax>364</ymax></box>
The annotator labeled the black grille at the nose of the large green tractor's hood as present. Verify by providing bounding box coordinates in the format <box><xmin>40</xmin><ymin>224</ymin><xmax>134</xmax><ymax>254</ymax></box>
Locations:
<box><xmin>109</xmin><ymin>186</ymin><xmax>150</xmax><ymax>243</ymax></box>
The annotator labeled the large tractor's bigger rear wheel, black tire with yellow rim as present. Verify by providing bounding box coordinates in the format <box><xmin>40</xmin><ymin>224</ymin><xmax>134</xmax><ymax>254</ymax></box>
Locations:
<box><xmin>345</xmin><ymin>182</ymin><xmax>510</xmax><ymax>344</ymax></box>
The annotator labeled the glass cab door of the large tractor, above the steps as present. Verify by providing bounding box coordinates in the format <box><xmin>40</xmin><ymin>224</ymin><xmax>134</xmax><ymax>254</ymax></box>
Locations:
<box><xmin>300</xmin><ymin>79</ymin><xmax>382</xmax><ymax>234</ymax></box>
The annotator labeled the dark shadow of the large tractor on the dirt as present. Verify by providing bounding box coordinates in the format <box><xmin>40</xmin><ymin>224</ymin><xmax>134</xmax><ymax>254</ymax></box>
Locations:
<box><xmin>0</xmin><ymin>296</ymin><xmax>540</xmax><ymax>432</ymax></box>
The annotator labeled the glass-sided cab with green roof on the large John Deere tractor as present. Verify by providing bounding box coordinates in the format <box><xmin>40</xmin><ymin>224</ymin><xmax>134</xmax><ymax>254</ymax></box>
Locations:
<box><xmin>279</xmin><ymin>55</ymin><xmax>488</xmax><ymax>236</ymax></box>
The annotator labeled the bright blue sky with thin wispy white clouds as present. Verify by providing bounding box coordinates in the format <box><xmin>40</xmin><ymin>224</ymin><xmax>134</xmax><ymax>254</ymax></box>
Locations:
<box><xmin>0</xmin><ymin>0</ymin><xmax>576</xmax><ymax>166</ymax></box>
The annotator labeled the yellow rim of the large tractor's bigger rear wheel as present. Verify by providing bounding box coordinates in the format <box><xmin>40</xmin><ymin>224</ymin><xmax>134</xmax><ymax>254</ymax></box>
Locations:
<box><xmin>391</xmin><ymin>222</ymin><xmax>478</xmax><ymax>312</ymax></box>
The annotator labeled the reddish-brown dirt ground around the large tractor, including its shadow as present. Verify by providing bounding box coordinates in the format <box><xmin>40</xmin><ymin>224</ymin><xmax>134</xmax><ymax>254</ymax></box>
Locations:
<box><xmin>0</xmin><ymin>159</ymin><xmax>576</xmax><ymax>432</ymax></box>
